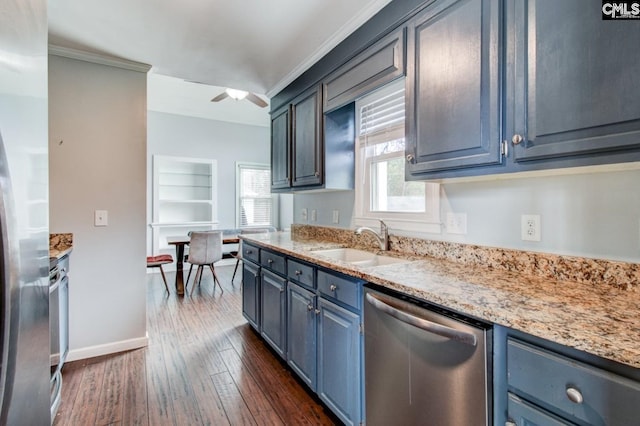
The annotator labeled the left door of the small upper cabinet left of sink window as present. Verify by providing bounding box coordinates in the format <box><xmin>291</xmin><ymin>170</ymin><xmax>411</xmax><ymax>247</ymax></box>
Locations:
<box><xmin>271</xmin><ymin>106</ymin><xmax>291</xmax><ymax>189</ymax></box>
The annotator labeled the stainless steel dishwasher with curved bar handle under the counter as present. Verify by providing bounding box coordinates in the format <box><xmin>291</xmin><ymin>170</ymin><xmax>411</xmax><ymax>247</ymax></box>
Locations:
<box><xmin>364</xmin><ymin>288</ymin><xmax>492</xmax><ymax>426</ymax></box>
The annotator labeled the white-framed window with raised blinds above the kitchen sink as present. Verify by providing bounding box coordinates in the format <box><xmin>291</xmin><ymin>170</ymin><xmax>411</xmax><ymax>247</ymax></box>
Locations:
<box><xmin>356</xmin><ymin>80</ymin><xmax>440</xmax><ymax>232</ymax></box>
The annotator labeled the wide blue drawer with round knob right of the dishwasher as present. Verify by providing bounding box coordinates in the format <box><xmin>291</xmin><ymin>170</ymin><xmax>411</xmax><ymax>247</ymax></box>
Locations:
<box><xmin>507</xmin><ymin>339</ymin><xmax>640</xmax><ymax>425</ymax></box>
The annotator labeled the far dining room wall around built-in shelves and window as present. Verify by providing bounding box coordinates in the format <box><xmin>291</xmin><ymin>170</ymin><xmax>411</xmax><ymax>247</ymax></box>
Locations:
<box><xmin>147</xmin><ymin>111</ymin><xmax>271</xmax><ymax>253</ymax></box>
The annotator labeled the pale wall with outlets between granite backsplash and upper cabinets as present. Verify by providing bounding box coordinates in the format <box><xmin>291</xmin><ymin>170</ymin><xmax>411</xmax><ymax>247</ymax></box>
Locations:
<box><xmin>294</xmin><ymin>169</ymin><xmax>640</xmax><ymax>262</ymax></box>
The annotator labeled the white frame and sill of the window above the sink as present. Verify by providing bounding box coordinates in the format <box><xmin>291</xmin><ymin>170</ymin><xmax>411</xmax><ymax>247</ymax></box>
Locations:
<box><xmin>354</xmin><ymin>79</ymin><xmax>442</xmax><ymax>233</ymax></box>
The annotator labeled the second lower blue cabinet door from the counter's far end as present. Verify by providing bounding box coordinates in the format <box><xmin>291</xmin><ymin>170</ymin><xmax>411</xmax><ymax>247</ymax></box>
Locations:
<box><xmin>260</xmin><ymin>269</ymin><xmax>286</xmax><ymax>358</ymax></box>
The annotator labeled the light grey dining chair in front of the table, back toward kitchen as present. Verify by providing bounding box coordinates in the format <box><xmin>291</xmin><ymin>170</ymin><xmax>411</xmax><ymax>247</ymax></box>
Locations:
<box><xmin>185</xmin><ymin>231</ymin><xmax>224</xmax><ymax>294</ymax></box>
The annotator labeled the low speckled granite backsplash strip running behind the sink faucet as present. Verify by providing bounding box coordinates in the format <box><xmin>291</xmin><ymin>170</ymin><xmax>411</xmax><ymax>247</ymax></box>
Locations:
<box><xmin>291</xmin><ymin>224</ymin><xmax>640</xmax><ymax>291</ymax></box>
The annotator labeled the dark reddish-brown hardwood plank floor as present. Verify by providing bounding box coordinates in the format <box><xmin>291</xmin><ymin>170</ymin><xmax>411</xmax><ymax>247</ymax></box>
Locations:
<box><xmin>54</xmin><ymin>266</ymin><xmax>338</xmax><ymax>426</ymax></box>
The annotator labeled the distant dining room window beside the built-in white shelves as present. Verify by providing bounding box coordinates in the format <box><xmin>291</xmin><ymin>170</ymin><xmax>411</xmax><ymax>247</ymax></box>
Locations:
<box><xmin>236</xmin><ymin>163</ymin><xmax>275</xmax><ymax>228</ymax></box>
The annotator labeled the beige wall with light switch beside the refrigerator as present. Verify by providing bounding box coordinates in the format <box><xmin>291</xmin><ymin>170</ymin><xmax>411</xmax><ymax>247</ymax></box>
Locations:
<box><xmin>49</xmin><ymin>55</ymin><xmax>147</xmax><ymax>359</ymax></box>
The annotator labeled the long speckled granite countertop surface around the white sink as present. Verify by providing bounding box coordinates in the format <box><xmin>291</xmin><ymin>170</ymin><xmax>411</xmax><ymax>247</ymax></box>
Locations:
<box><xmin>241</xmin><ymin>233</ymin><xmax>640</xmax><ymax>368</ymax></box>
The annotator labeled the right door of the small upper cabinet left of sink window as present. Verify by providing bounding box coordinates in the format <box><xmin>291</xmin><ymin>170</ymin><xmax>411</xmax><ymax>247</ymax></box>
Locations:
<box><xmin>291</xmin><ymin>88</ymin><xmax>324</xmax><ymax>186</ymax></box>
